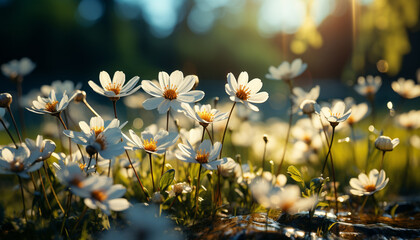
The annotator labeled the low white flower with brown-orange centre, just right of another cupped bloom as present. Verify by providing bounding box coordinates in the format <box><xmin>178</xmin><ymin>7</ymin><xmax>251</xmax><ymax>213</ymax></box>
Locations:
<box><xmin>176</xmin><ymin>140</ymin><xmax>227</xmax><ymax>170</ymax></box>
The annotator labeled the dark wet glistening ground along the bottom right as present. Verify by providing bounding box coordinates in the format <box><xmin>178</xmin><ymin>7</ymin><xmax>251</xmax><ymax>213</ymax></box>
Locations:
<box><xmin>190</xmin><ymin>202</ymin><xmax>420</xmax><ymax>240</ymax></box>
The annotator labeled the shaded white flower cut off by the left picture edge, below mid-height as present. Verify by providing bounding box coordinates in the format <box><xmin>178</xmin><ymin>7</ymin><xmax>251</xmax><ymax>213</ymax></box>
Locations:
<box><xmin>0</xmin><ymin>145</ymin><xmax>43</xmax><ymax>178</ymax></box>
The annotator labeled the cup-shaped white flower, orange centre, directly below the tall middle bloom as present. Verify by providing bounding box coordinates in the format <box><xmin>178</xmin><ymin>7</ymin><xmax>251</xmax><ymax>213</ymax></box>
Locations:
<box><xmin>124</xmin><ymin>129</ymin><xmax>179</xmax><ymax>154</ymax></box>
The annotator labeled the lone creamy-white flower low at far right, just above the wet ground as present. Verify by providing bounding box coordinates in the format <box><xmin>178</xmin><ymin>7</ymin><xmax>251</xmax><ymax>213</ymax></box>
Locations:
<box><xmin>350</xmin><ymin>169</ymin><xmax>389</xmax><ymax>196</ymax></box>
